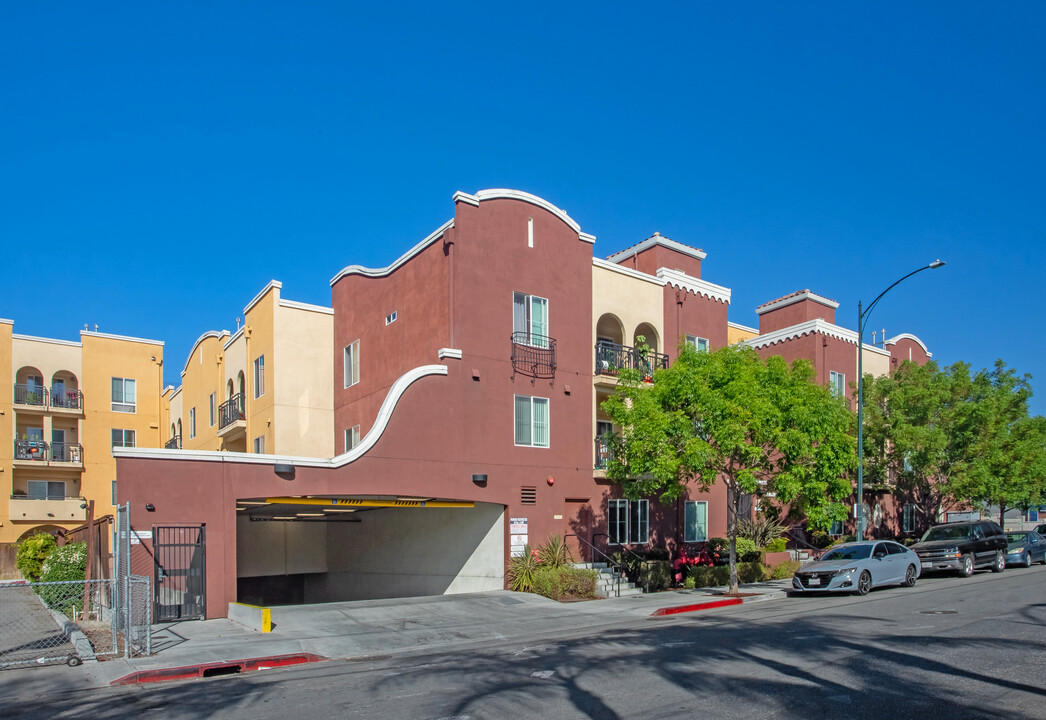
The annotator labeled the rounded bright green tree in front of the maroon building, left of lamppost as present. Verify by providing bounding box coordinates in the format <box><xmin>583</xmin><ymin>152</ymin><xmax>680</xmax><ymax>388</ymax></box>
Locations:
<box><xmin>602</xmin><ymin>345</ymin><xmax>857</xmax><ymax>592</ymax></box>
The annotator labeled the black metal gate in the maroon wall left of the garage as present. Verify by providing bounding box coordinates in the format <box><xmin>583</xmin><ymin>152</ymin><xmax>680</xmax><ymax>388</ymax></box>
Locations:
<box><xmin>153</xmin><ymin>525</ymin><xmax>207</xmax><ymax>623</ymax></box>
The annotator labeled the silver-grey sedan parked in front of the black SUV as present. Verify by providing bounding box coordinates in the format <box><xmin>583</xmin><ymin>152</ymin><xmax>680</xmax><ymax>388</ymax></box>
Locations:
<box><xmin>792</xmin><ymin>540</ymin><xmax>920</xmax><ymax>595</ymax></box>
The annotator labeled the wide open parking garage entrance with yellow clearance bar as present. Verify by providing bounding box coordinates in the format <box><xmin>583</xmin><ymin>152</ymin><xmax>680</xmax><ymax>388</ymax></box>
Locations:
<box><xmin>236</xmin><ymin>496</ymin><xmax>504</xmax><ymax>605</ymax></box>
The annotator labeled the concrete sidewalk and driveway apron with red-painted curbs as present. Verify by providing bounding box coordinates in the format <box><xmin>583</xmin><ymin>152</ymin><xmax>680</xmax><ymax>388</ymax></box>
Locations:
<box><xmin>0</xmin><ymin>580</ymin><xmax>790</xmax><ymax>689</ymax></box>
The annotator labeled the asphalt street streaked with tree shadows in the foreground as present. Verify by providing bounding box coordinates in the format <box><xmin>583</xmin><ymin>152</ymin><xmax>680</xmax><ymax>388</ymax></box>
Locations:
<box><xmin>2</xmin><ymin>566</ymin><xmax>1046</xmax><ymax>720</ymax></box>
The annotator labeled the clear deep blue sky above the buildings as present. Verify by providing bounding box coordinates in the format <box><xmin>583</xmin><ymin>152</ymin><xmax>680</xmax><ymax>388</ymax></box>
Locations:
<box><xmin>0</xmin><ymin>2</ymin><xmax>1046</xmax><ymax>413</ymax></box>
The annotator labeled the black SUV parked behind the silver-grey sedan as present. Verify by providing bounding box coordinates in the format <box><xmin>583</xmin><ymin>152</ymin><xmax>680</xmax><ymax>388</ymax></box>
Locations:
<box><xmin>912</xmin><ymin>520</ymin><xmax>1006</xmax><ymax>578</ymax></box>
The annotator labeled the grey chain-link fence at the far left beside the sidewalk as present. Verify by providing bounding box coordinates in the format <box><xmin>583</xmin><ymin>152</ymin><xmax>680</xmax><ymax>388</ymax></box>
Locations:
<box><xmin>0</xmin><ymin>508</ymin><xmax>153</xmax><ymax>669</ymax></box>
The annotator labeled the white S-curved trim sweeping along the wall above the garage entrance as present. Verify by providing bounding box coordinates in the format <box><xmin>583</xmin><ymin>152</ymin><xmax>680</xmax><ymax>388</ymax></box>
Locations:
<box><xmin>113</xmin><ymin>365</ymin><xmax>447</xmax><ymax>469</ymax></box>
